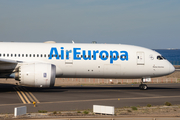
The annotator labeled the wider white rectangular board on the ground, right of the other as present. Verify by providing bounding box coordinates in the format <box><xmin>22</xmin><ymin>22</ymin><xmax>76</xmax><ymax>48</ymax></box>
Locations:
<box><xmin>93</xmin><ymin>105</ymin><xmax>114</xmax><ymax>115</ymax></box>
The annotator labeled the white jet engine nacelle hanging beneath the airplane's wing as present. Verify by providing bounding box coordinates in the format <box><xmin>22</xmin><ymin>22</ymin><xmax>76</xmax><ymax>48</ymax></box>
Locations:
<box><xmin>15</xmin><ymin>63</ymin><xmax>56</xmax><ymax>87</ymax></box>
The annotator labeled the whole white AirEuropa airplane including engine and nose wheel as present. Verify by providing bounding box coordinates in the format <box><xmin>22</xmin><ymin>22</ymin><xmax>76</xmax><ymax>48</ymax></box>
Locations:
<box><xmin>0</xmin><ymin>41</ymin><xmax>175</xmax><ymax>90</ymax></box>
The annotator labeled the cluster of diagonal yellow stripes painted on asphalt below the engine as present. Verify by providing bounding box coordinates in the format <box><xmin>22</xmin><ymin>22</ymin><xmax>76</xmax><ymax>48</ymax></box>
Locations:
<box><xmin>13</xmin><ymin>86</ymin><xmax>40</xmax><ymax>104</ymax></box>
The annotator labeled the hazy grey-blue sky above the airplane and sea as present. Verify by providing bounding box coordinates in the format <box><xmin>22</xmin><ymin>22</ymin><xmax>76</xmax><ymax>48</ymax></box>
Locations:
<box><xmin>0</xmin><ymin>0</ymin><xmax>180</xmax><ymax>49</ymax></box>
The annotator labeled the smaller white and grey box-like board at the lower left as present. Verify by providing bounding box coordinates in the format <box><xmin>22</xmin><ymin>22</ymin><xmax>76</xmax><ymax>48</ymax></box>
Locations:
<box><xmin>14</xmin><ymin>106</ymin><xmax>27</xmax><ymax>117</ymax></box>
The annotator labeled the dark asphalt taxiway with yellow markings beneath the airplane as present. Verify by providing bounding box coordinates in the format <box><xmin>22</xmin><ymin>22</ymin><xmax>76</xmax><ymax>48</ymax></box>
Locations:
<box><xmin>0</xmin><ymin>83</ymin><xmax>180</xmax><ymax>113</ymax></box>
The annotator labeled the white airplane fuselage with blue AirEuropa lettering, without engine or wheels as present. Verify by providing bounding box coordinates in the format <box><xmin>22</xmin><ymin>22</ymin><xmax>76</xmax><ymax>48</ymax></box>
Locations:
<box><xmin>0</xmin><ymin>42</ymin><xmax>174</xmax><ymax>78</ymax></box>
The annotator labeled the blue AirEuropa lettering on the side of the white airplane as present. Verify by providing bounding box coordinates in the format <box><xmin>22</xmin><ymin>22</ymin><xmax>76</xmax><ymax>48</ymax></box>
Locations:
<box><xmin>49</xmin><ymin>47</ymin><xmax>128</xmax><ymax>64</ymax></box>
